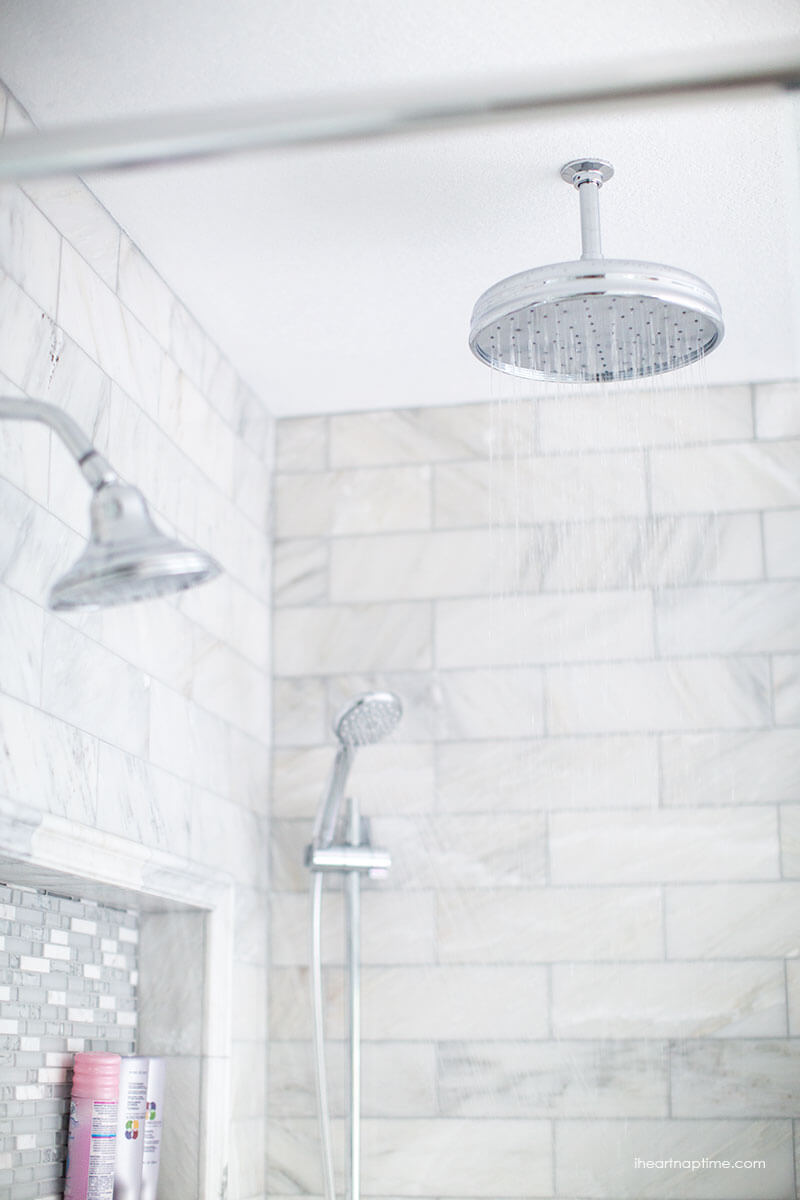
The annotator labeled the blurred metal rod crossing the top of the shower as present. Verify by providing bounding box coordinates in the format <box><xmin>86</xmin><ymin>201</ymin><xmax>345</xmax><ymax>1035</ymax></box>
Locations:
<box><xmin>0</xmin><ymin>41</ymin><xmax>800</xmax><ymax>182</ymax></box>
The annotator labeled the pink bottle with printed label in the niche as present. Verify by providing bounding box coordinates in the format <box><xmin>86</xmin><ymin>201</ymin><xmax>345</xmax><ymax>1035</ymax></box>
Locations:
<box><xmin>64</xmin><ymin>1052</ymin><xmax>121</xmax><ymax>1200</ymax></box>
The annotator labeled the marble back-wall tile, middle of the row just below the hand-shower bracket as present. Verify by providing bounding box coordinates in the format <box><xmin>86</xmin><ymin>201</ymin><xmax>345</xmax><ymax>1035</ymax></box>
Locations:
<box><xmin>438</xmin><ymin>887</ymin><xmax>663</xmax><ymax>964</ymax></box>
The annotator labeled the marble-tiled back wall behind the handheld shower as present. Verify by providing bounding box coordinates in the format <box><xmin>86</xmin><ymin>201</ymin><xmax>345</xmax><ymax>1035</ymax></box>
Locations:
<box><xmin>269</xmin><ymin>383</ymin><xmax>800</xmax><ymax>1200</ymax></box>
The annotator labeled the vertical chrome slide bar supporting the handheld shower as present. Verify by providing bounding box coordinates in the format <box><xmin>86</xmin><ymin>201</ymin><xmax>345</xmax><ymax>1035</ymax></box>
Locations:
<box><xmin>345</xmin><ymin>799</ymin><xmax>361</xmax><ymax>1200</ymax></box>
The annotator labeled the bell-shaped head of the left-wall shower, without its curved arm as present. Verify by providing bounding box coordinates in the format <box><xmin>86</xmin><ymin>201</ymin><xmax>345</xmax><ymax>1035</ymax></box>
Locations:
<box><xmin>49</xmin><ymin>482</ymin><xmax>221</xmax><ymax>610</ymax></box>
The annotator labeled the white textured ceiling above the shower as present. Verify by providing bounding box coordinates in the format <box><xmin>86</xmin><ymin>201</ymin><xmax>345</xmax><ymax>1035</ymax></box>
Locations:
<box><xmin>0</xmin><ymin>0</ymin><xmax>800</xmax><ymax>415</ymax></box>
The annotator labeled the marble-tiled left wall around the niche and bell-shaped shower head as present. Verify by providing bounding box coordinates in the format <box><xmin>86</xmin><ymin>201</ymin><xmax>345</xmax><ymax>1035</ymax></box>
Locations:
<box><xmin>0</xmin><ymin>89</ymin><xmax>273</xmax><ymax>1200</ymax></box>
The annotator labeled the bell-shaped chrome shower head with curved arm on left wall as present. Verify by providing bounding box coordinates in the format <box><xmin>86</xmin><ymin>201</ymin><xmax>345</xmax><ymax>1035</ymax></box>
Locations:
<box><xmin>0</xmin><ymin>396</ymin><xmax>221</xmax><ymax>610</ymax></box>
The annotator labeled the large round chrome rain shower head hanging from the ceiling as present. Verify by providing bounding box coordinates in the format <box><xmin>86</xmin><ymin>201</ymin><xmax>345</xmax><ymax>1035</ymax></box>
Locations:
<box><xmin>469</xmin><ymin>158</ymin><xmax>724</xmax><ymax>383</ymax></box>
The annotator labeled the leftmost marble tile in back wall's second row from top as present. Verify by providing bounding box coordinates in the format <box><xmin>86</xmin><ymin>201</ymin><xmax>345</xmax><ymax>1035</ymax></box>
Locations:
<box><xmin>275</xmin><ymin>467</ymin><xmax>431</xmax><ymax>538</ymax></box>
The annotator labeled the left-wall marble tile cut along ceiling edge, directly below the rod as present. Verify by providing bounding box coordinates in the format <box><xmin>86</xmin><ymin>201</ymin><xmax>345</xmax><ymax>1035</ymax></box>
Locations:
<box><xmin>25</xmin><ymin>176</ymin><xmax>120</xmax><ymax>288</ymax></box>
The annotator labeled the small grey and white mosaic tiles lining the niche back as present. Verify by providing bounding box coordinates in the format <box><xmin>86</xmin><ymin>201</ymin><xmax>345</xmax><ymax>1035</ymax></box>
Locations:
<box><xmin>0</xmin><ymin>883</ymin><xmax>139</xmax><ymax>1200</ymax></box>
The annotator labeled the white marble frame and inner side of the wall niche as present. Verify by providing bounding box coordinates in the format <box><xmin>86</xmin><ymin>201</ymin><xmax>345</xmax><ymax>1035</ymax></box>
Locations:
<box><xmin>0</xmin><ymin>797</ymin><xmax>234</xmax><ymax>1200</ymax></box>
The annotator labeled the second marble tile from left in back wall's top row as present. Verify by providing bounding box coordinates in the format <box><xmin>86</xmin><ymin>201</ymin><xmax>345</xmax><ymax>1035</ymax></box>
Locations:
<box><xmin>330</xmin><ymin>404</ymin><xmax>503</xmax><ymax>468</ymax></box>
